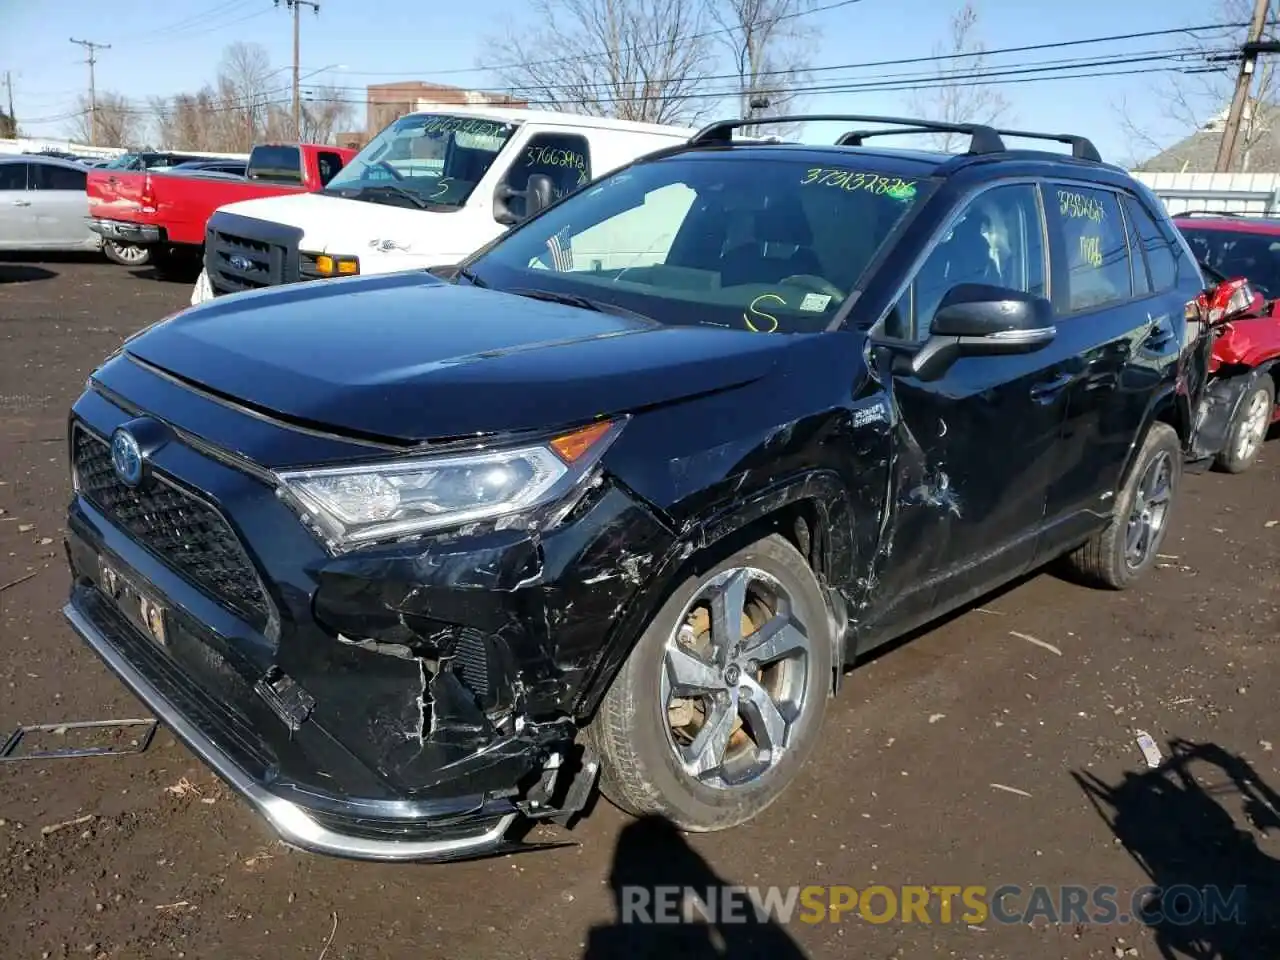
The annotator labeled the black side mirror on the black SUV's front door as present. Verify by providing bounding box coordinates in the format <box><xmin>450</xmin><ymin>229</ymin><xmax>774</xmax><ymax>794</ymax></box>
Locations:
<box><xmin>893</xmin><ymin>283</ymin><xmax>1057</xmax><ymax>380</ymax></box>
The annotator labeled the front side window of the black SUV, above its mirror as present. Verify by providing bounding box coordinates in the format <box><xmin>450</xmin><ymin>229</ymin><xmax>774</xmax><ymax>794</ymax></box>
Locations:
<box><xmin>883</xmin><ymin>183</ymin><xmax>1046</xmax><ymax>340</ymax></box>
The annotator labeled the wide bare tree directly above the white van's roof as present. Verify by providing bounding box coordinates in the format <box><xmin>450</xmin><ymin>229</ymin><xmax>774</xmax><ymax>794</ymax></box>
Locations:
<box><xmin>481</xmin><ymin>0</ymin><xmax>713</xmax><ymax>123</ymax></box>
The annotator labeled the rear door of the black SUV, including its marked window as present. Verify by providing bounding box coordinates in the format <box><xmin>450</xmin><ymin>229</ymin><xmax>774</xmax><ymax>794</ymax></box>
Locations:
<box><xmin>1042</xmin><ymin>182</ymin><xmax>1185</xmax><ymax>554</ymax></box>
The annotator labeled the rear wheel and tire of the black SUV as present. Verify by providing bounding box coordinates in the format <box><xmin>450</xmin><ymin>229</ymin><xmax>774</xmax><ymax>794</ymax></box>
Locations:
<box><xmin>1066</xmin><ymin>422</ymin><xmax>1183</xmax><ymax>590</ymax></box>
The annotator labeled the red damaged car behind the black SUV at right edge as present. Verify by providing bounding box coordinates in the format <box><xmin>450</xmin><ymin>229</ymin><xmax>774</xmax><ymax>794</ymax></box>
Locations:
<box><xmin>1174</xmin><ymin>214</ymin><xmax>1280</xmax><ymax>474</ymax></box>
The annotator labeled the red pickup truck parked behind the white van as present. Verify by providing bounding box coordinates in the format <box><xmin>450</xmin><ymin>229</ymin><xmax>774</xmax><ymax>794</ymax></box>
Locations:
<box><xmin>86</xmin><ymin>143</ymin><xmax>356</xmax><ymax>270</ymax></box>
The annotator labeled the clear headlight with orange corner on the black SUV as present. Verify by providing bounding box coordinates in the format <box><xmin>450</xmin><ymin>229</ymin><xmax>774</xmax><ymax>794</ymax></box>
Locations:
<box><xmin>278</xmin><ymin>420</ymin><xmax>623</xmax><ymax>545</ymax></box>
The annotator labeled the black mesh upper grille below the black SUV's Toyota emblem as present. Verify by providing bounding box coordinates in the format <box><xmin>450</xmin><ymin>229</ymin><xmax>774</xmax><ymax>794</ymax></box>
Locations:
<box><xmin>72</xmin><ymin>428</ymin><xmax>270</xmax><ymax>630</ymax></box>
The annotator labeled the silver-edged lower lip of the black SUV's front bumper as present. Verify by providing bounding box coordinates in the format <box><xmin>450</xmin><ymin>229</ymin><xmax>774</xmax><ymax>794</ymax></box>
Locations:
<box><xmin>63</xmin><ymin>588</ymin><xmax>517</xmax><ymax>860</ymax></box>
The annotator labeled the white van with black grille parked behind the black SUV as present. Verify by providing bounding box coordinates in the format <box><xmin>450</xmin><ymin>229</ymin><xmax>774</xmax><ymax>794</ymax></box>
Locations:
<box><xmin>191</xmin><ymin>106</ymin><xmax>695</xmax><ymax>303</ymax></box>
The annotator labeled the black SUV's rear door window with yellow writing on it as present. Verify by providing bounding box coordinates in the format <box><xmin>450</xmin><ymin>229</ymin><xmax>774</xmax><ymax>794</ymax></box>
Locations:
<box><xmin>1044</xmin><ymin>183</ymin><xmax>1133</xmax><ymax>314</ymax></box>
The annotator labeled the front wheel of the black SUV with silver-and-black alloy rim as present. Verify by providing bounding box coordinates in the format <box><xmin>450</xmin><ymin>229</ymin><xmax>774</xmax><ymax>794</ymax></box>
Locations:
<box><xmin>588</xmin><ymin>535</ymin><xmax>832</xmax><ymax>832</ymax></box>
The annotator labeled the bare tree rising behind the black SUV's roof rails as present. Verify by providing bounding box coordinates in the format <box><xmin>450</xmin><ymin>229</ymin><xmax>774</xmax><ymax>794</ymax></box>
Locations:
<box><xmin>910</xmin><ymin>0</ymin><xmax>1010</xmax><ymax>151</ymax></box>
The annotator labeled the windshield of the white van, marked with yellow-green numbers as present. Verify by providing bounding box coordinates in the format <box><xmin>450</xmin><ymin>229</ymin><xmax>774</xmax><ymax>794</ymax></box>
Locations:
<box><xmin>324</xmin><ymin>114</ymin><xmax>516</xmax><ymax>207</ymax></box>
